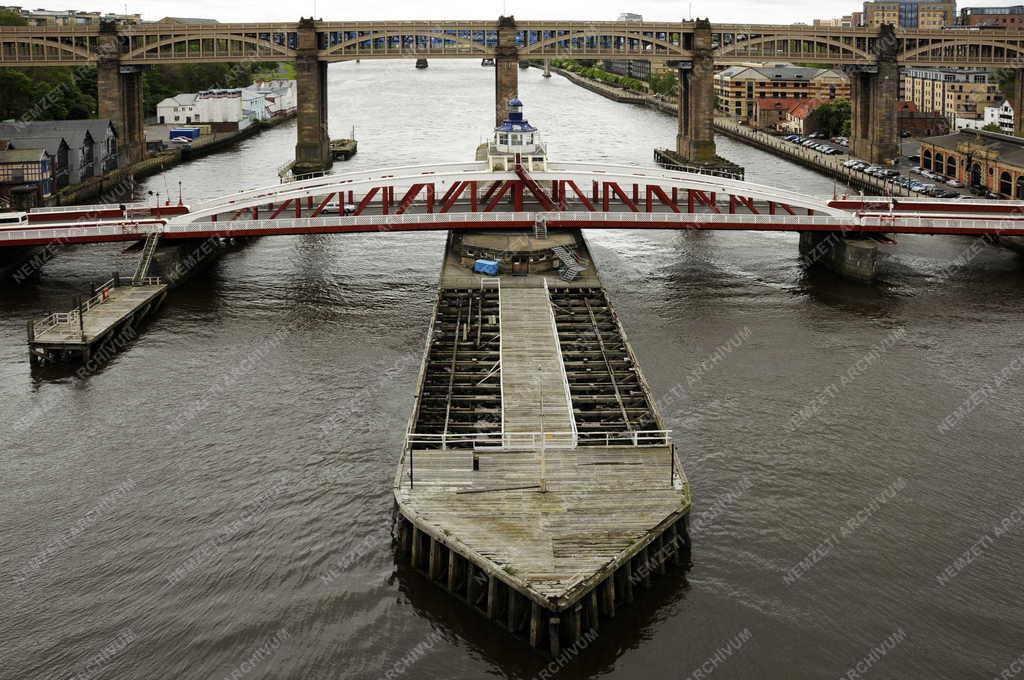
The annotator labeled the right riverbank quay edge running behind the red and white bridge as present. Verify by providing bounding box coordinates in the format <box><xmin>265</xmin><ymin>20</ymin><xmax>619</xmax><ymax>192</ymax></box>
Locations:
<box><xmin>551</xmin><ymin>68</ymin><xmax>923</xmax><ymax>196</ymax></box>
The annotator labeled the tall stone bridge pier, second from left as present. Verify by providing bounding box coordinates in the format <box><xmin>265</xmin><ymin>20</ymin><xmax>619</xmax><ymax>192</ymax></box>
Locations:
<box><xmin>292</xmin><ymin>18</ymin><xmax>334</xmax><ymax>175</ymax></box>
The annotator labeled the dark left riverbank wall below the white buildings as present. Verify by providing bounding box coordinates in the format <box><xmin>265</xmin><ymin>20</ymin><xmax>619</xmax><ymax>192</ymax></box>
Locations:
<box><xmin>43</xmin><ymin>114</ymin><xmax>295</xmax><ymax>206</ymax></box>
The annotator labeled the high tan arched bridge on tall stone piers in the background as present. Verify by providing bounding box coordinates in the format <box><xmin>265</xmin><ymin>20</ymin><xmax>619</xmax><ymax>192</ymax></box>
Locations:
<box><xmin>0</xmin><ymin>16</ymin><xmax>1024</xmax><ymax>168</ymax></box>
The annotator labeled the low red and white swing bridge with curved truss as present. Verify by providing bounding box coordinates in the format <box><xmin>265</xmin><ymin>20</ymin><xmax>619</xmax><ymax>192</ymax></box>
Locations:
<box><xmin>6</xmin><ymin>162</ymin><xmax>1024</xmax><ymax>248</ymax></box>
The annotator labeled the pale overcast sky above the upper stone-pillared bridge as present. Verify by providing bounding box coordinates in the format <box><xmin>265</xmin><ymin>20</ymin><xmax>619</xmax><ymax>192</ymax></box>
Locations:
<box><xmin>72</xmin><ymin>0</ymin><xmax>1016</xmax><ymax>24</ymax></box>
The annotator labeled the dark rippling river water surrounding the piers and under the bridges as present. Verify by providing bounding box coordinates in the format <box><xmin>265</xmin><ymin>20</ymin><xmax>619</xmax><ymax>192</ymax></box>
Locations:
<box><xmin>0</xmin><ymin>61</ymin><xmax>1024</xmax><ymax>680</ymax></box>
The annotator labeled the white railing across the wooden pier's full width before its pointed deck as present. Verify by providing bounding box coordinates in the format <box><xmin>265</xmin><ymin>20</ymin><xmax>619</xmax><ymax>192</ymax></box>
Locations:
<box><xmin>406</xmin><ymin>430</ymin><xmax>672</xmax><ymax>450</ymax></box>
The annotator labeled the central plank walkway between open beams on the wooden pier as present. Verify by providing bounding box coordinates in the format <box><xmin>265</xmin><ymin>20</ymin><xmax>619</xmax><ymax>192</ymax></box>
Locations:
<box><xmin>501</xmin><ymin>288</ymin><xmax>572</xmax><ymax>432</ymax></box>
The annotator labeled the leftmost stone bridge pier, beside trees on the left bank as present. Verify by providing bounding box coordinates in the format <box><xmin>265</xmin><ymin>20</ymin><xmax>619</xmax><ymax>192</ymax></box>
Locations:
<box><xmin>96</xmin><ymin>22</ymin><xmax>146</xmax><ymax>165</ymax></box>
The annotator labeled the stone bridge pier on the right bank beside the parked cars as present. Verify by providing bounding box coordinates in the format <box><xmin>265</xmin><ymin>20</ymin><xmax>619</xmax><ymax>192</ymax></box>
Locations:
<box><xmin>844</xmin><ymin>24</ymin><xmax>899</xmax><ymax>163</ymax></box>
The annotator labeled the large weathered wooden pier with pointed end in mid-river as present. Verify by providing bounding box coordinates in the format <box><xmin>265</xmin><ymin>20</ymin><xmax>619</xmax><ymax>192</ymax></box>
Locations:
<box><xmin>394</xmin><ymin>235</ymin><xmax>690</xmax><ymax>654</ymax></box>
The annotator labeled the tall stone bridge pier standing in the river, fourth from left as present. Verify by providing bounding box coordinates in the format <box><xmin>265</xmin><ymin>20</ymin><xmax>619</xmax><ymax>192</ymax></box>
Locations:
<box><xmin>674</xmin><ymin>19</ymin><xmax>717</xmax><ymax>164</ymax></box>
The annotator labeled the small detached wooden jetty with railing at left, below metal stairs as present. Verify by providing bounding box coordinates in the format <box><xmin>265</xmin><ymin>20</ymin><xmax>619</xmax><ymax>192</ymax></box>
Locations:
<box><xmin>28</xmin><ymin>275</ymin><xmax>167</xmax><ymax>365</ymax></box>
